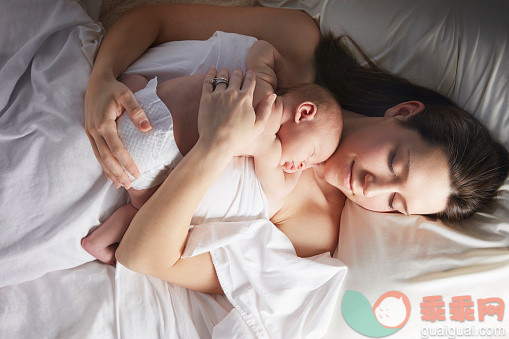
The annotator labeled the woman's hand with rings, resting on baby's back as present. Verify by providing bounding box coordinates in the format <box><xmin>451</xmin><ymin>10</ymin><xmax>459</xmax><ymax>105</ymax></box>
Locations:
<box><xmin>198</xmin><ymin>69</ymin><xmax>276</xmax><ymax>156</ymax></box>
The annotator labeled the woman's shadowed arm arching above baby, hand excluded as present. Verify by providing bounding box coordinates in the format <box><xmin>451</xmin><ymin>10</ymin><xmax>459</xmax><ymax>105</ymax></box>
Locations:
<box><xmin>94</xmin><ymin>4</ymin><xmax>320</xmax><ymax>82</ymax></box>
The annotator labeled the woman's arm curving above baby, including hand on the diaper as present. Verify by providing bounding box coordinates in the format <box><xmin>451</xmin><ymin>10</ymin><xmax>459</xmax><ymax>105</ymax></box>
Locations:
<box><xmin>85</xmin><ymin>4</ymin><xmax>320</xmax><ymax>188</ymax></box>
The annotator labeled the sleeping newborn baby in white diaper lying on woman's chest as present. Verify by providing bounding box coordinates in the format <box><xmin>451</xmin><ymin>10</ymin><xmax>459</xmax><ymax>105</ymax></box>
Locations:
<box><xmin>82</xmin><ymin>41</ymin><xmax>342</xmax><ymax>265</ymax></box>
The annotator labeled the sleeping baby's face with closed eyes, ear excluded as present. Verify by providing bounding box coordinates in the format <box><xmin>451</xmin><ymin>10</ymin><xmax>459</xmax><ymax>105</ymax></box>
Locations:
<box><xmin>277</xmin><ymin>113</ymin><xmax>341</xmax><ymax>173</ymax></box>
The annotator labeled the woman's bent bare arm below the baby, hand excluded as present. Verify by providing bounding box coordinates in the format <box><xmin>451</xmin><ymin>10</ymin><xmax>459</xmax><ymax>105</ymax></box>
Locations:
<box><xmin>115</xmin><ymin>141</ymin><xmax>232</xmax><ymax>293</ymax></box>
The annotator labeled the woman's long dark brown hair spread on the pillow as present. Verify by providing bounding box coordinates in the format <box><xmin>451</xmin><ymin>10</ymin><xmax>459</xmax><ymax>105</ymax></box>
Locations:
<box><xmin>315</xmin><ymin>33</ymin><xmax>509</xmax><ymax>222</ymax></box>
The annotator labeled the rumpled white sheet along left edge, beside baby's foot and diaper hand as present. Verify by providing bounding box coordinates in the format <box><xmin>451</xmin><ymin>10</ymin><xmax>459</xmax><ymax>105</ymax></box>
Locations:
<box><xmin>0</xmin><ymin>1</ymin><xmax>110</xmax><ymax>286</ymax></box>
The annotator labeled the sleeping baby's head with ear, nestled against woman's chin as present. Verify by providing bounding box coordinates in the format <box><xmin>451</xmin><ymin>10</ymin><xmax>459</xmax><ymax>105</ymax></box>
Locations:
<box><xmin>277</xmin><ymin>84</ymin><xmax>343</xmax><ymax>173</ymax></box>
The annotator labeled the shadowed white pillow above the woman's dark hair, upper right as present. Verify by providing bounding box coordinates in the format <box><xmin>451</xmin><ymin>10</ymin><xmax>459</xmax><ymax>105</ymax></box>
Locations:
<box><xmin>259</xmin><ymin>0</ymin><xmax>509</xmax><ymax>147</ymax></box>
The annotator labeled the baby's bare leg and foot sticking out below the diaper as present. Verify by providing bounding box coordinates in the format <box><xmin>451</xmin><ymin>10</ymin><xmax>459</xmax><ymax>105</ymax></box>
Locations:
<box><xmin>81</xmin><ymin>186</ymin><xmax>157</xmax><ymax>266</ymax></box>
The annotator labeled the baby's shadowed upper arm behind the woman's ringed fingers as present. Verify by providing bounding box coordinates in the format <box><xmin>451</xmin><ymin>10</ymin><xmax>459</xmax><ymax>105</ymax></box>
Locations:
<box><xmin>246</xmin><ymin>40</ymin><xmax>288</xmax><ymax>107</ymax></box>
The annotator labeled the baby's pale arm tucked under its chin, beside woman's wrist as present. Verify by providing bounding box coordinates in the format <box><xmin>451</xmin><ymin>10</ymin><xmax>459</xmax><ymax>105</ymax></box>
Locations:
<box><xmin>254</xmin><ymin>135</ymin><xmax>302</xmax><ymax>205</ymax></box>
